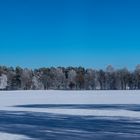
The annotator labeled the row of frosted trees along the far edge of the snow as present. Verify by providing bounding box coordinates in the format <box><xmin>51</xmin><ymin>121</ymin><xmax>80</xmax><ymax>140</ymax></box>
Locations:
<box><xmin>0</xmin><ymin>65</ymin><xmax>140</xmax><ymax>90</ymax></box>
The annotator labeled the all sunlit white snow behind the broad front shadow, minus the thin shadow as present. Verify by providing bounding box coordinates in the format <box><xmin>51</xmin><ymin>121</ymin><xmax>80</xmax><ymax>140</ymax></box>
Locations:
<box><xmin>0</xmin><ymin>90</ymin><xmax>140</xmax><ymax>118</ymax></box>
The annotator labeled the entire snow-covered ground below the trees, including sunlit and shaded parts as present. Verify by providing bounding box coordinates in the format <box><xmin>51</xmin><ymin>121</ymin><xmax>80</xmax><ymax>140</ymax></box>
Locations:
<box><xmin>0</xmin><ymin>91</ymin><xmax>140</xmax><ymax>140</ymax></box>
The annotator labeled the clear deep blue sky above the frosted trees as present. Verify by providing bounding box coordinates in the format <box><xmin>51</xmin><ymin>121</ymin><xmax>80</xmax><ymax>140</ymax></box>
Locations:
<box><xmin>0</xmin><ymin>0</ymin><xmax>140</xmax><ymax>69</ymax></box>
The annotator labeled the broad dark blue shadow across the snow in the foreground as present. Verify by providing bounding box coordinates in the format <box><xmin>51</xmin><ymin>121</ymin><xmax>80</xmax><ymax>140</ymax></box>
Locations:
<box><xmin>0</xmin><ymin>105</ymin><xmax>140</xmax><ymax>140</ymax></box>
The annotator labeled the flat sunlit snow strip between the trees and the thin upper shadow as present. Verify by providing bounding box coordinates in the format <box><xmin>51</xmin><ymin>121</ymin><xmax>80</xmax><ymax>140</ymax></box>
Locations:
<box><xmin>0</xmin><ymin>90</ymin><xmax>140</xmax><ymax>106</ymax></box>
